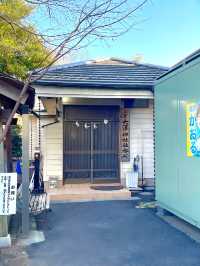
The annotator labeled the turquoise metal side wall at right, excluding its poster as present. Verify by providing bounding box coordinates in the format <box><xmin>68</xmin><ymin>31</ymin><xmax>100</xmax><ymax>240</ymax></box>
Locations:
<box><xmin>155</xmin><ymin>58</ymin><xmax>200</xmax><ymax>228</ymax></box>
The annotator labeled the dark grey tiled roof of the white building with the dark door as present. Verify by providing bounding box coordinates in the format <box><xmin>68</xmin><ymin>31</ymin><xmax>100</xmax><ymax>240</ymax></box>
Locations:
<box><xmin>32</xmin><ymin>59</ymin><xmax>168</xmax><ymax>89</ymax></box>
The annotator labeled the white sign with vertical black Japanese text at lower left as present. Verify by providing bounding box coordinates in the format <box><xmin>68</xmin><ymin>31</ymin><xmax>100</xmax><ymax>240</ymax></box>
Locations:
<box><xmin>0</xmin><ymin>173</ymin><xmax>17</xmax><ymax>215</ymax></box>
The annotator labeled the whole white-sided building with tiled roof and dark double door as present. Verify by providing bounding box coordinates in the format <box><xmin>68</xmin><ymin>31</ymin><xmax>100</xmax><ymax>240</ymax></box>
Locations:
<box><xmin>30</xmin><ymin>59</ymin><xmax>166</xmax><ymax>190</ymax></box>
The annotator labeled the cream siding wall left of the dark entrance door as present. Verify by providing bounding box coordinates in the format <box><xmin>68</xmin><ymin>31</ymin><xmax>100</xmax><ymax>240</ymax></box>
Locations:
<box><xmin>29</xmin><ymin>111</ymin><xmax>63</xmax><ymax>181</ymax></box>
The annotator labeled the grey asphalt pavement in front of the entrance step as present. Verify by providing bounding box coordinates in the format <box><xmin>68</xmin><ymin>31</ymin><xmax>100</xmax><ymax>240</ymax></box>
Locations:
<box><xmin>27</xmin><ymin>198</ymin><xmax>200</xmax><ymax>266</ymax></box>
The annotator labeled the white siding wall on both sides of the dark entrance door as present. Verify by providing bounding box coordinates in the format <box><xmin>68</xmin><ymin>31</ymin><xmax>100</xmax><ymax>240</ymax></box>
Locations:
<box><xmin>32</xmin><ymin>96</ymin><xmax>154</xmax><ymax>187</ymax></box>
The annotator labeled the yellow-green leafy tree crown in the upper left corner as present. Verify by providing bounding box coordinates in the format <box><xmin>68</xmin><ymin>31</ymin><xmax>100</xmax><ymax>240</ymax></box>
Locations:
<box><xmin>0</xmin><ymin>0</ymin><xmax>48</xmax><ymax>79</ymax></box>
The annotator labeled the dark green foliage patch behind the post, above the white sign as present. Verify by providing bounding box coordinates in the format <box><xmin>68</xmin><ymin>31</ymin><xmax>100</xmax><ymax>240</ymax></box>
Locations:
<box><xmin>11</xmin><ymin>125</ymin><xmax>22</xmax><ymax>158</ymax></box>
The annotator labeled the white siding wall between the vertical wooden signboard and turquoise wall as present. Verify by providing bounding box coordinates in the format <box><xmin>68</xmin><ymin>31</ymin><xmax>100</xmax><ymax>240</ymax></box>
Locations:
<box><xmin>121</xmin><ymin>104</ymin><xmax>154</xmax><ymax>186</ymax></box>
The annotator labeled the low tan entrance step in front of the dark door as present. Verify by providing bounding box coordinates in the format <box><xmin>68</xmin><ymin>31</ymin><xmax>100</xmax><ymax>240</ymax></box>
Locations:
<box><xmin>49</xmin><ymin>183</ymin><xmax>131</xmax><ymax>201</ymax></box>
